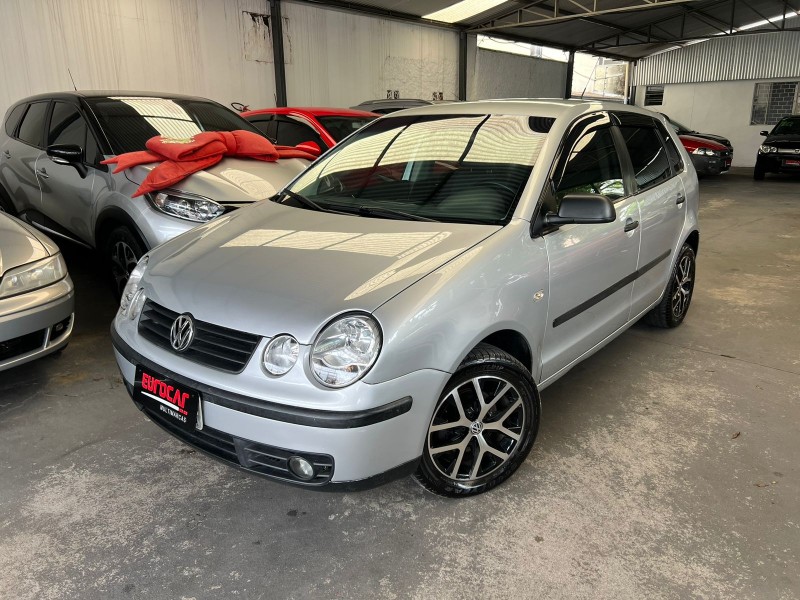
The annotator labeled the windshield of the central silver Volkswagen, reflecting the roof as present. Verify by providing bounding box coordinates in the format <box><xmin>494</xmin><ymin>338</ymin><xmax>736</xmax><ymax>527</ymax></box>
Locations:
<box><xmin>276</xmin><ymin>115</ymin><xmax>553</xmax><ymax>225</ymax></box>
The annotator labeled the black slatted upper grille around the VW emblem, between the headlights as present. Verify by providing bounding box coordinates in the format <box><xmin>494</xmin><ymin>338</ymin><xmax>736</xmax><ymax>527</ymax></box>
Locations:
<box><xmin>139</xmin><ymin>300</ymin><xmax>261</xmax><ymax>373</ymax></box>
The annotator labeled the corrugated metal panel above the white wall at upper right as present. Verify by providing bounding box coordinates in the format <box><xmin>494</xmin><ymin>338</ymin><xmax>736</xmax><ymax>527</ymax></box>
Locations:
<box><xmin>635</xmin><ymin>31</ymin><xmax>800</xmax><ymax>85</ymax></box>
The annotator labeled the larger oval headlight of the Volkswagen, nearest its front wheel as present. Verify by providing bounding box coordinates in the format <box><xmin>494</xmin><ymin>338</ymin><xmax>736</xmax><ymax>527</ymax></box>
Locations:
<box><xmin>311</xmin><ymin>314</ymin><xmax>381</xmax><ymax>388</ymax></box>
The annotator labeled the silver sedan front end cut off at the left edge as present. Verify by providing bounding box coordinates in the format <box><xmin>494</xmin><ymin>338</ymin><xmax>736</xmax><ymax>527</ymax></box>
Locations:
<box><xmin>0</xmin><ymin>210</ymin><xmax>75</xmax><ymax>371</ymax></box>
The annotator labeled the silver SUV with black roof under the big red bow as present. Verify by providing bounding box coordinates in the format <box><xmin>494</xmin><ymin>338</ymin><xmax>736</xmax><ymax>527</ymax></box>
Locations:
<box><xmin>0</xmin><ymin>91</ymin><xmax>308</xmax><ymax>294</ymax></box>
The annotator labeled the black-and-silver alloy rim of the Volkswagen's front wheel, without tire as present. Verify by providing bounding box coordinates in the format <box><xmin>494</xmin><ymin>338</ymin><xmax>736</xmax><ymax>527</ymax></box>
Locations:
<box><xmin>426</xmin><ymin>376</ymin><xmax>528</xmax><ymax>483</ymax></box>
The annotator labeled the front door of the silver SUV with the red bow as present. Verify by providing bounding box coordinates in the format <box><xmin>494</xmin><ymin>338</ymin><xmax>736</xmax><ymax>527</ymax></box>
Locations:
<box><xmin>37</xmin><ymin>101</ymin><xmax>102</xmax><ymax>243</ymax></box>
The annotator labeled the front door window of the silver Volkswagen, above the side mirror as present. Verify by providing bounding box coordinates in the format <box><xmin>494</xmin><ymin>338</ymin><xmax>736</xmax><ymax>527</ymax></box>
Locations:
<box><xmin>556</xmin><ymin>127</ymin><xmax>625</xmax><ymax>199</ymax></box>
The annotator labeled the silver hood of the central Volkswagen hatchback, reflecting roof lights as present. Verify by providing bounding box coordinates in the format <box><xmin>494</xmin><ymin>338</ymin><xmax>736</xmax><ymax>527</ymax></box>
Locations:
<box><xmin>144</xmin><ymin>201</ymin><xmax>500</xmax><ymax>344</ymax></box>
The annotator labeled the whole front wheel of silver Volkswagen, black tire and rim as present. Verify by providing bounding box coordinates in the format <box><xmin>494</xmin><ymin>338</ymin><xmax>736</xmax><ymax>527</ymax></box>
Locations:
<box><xmin>414</xmin><ymin>344</ymin><xmax>542</xmax><ymax>497</ymax></box>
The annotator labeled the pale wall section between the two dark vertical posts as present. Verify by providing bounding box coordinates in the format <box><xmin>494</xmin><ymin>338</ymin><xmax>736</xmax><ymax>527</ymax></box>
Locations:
<box><xmin>281</xmin><ymin>2</ymin><xmax>458</xmax><ymax>106</ymax></box>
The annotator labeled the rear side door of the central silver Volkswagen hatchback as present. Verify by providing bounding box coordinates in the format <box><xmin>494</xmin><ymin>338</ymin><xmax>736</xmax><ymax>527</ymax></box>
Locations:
<box><xmin>615</xmin><ymin>113</ymin><xmax>686</xmax><ymax>318</ymax></box>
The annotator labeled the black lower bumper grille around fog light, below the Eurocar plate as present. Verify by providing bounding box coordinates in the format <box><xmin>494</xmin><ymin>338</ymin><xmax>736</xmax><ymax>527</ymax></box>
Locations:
<box><xmin>143</xmin><ymin>400</ymin><xmax>333</xmax><ymax>485</ymax></box>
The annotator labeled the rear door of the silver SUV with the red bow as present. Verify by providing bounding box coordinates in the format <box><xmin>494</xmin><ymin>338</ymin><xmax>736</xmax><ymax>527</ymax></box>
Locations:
<box><xmin>2</xmin><ymin>100</ymin><xmax>50</xmax><ymax>216</ymax></box>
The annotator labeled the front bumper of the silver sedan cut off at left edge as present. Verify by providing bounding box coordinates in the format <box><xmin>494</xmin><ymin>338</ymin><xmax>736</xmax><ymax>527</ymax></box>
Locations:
<box><xmin>0</xmin><ymin>276</ymin><xmax>75</xmax><ymax>371</ymax></box>
